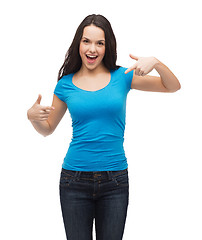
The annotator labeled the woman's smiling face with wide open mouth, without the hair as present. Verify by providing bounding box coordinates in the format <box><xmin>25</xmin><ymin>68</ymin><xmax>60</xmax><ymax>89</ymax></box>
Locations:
<box><xmin>79</xmin><ymin>25</ymin><xmax>105</xmax><ymax>70</ymax></box>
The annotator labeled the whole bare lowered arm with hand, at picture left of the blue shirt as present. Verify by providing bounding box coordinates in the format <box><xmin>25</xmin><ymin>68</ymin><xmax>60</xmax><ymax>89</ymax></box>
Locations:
<box><xmin>27</xmin><ymin>95</ymin><xmax>67</xmax><ymax>137</ymax></box>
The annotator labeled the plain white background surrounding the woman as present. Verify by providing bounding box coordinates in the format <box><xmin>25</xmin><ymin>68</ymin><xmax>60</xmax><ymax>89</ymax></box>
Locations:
<box><xmin>0</xmin><ymin>0</ymin><xmax>202</xmax><ymax>240</ymax></box>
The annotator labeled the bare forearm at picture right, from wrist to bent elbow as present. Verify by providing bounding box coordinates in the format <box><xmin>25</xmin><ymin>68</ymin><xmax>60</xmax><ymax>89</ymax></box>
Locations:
<box><xmin>154</xmin><ymin>59</ymin><xmax>181</xmax><ymax>91</ymax></box>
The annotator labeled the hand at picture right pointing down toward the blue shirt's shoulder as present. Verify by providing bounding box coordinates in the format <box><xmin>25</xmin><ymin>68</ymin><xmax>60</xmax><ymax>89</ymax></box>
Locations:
<box><xmin>125</xmin><ymin>54</ymin><xmax>158</xmax><ymax>76</ymax></box>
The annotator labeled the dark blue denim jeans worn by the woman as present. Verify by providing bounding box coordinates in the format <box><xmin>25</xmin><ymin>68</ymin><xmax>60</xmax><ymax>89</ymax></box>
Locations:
<box><xmin>60</xmin><ymin>169</ymin><xmax>129</xmax><ymax>240</ymax></box>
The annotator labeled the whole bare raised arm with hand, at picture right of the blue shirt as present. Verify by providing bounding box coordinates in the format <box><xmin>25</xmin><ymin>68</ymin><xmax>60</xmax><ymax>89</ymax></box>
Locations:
<box><xmin>125</xmin><ymin>55</ymin><xmax>181</xmax><ymax>92</ymax></box>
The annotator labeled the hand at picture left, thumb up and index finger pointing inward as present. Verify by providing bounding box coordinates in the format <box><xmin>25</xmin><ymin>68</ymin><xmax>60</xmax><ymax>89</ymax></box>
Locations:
<box><xmin>27</xmin><ymin>94</ymin><xmax>55</xmax><ymax>121</ymax></box>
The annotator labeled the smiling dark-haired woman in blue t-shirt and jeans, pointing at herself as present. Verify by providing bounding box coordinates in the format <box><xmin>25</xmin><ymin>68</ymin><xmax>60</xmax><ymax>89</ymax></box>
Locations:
<box><xmin>28</xmin><ymin>14</ymin><xmax>180</xmax><ymax>240</ymax></box>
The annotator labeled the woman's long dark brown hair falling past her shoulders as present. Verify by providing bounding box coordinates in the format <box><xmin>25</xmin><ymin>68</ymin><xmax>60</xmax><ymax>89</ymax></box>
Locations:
<box><xmin>58</xmin><ymin>14</ymin><xmax>119</xmax><ymax>81</ymax></box>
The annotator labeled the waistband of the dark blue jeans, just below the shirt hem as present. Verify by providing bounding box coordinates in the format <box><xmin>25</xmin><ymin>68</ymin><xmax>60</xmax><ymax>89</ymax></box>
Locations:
<box><xmin>62</xmin><ymin>168</ymin><xmax>128</xmax><ymax>180</ymax></box>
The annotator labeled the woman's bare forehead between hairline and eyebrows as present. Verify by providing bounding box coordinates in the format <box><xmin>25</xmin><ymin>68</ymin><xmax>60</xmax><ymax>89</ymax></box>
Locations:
<box><xmin>82</xmin><ymin>25</ymin><xmax>105</xmax><ymax>40</ymax></box>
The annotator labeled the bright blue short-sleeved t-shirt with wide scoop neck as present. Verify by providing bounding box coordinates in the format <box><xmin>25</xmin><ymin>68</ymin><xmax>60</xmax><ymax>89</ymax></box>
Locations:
<box><xmin>54</xmin><ymin>67</ymin><xmax>133</xmax><ymax>171</ymax></box>
